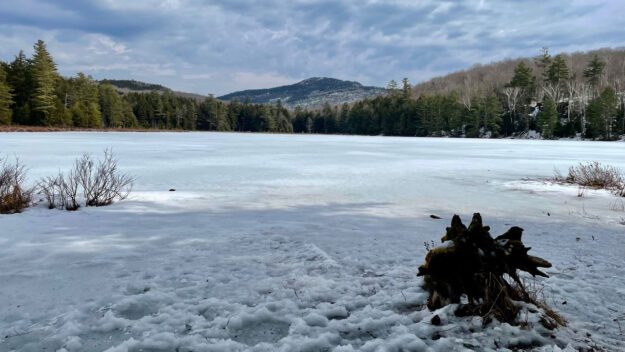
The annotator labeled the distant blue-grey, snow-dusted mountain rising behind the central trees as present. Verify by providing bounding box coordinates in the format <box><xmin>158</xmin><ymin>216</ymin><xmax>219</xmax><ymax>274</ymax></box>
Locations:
<box><xmin>218</xmin><ymin>77</ymin><xmax>386</xmax><ymax>108</ymax></box>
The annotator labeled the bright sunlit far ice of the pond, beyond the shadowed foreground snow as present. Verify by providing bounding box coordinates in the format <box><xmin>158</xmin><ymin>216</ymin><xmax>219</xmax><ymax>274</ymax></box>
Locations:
<box><xmin>0</xmin><ymin>133</ymin><xmax>625</xmax><ymax>220</ymax></box>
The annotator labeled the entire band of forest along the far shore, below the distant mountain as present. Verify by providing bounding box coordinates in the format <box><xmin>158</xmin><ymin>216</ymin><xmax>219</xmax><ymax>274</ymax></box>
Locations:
<box><xmin>0</xmin><ymin>40</ymin><xmax>625</xmax><ymax>140</ymax></box>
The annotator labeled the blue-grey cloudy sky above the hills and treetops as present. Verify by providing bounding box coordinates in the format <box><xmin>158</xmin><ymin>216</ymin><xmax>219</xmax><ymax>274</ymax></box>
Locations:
<box><xmin>0</xmin><ymin>0</ymin><xmax>625</xmax><ymax>95</ymax></box>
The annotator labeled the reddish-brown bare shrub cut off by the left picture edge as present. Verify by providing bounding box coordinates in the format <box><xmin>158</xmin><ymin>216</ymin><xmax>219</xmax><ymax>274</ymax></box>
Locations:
<box><xmin>0</xmin><ymin>159</ymin><xmax>32</xmax><ymax>214</ymax></box>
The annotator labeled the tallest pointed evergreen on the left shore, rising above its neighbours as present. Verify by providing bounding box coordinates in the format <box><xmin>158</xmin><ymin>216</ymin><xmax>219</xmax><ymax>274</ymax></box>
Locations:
<box><xmin>31</xmin><ymin>40</ymin><xmax>58</xmax><ymax>125</ymax></box>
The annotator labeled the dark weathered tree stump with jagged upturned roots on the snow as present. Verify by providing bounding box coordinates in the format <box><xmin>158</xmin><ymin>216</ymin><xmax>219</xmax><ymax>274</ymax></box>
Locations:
<box><xmin>417</xmin><ymin>213</ymin><xmax>564</xmax><ymax>328</ymax></box>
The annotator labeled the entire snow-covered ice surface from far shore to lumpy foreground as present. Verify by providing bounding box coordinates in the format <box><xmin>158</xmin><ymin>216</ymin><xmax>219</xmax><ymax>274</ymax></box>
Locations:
<box><xmin>0</xmin><ymin>133</ymin><xmax>625</xmax><ymax>351</ymax></box>
